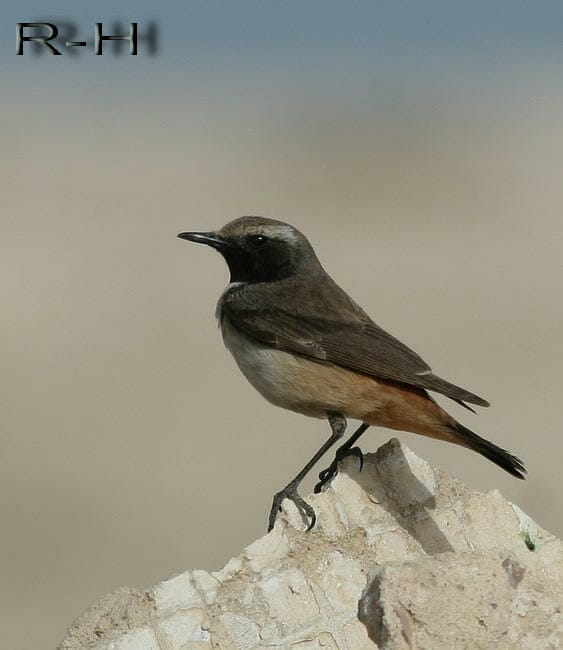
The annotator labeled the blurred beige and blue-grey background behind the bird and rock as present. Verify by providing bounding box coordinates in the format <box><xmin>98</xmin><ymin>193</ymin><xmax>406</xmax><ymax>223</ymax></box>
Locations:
<box><xmin>0</xmin><ymin>0</ymin><xmax>563</xmax><ymax>650</ymax></box>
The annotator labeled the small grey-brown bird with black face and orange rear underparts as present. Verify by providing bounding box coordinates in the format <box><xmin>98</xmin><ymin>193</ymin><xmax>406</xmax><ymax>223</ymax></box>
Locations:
<box><xmin>178</xmin><ymin>216</ymin><xmax>526</xmax><ymax>531</ymax></box>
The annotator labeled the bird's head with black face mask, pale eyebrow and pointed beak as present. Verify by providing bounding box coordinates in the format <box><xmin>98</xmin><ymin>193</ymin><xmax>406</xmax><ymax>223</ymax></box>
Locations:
<box><xmin>178</xmin><ymin>217</ymin><xmax>320</xmax><ymax>282</ymax></box>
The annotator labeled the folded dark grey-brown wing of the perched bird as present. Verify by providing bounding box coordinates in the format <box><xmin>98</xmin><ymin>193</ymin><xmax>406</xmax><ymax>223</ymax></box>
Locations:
<box><xmin>224</xmin><ymin>303</ymin><xmax>489</xmax><ymax>406</ymax></box>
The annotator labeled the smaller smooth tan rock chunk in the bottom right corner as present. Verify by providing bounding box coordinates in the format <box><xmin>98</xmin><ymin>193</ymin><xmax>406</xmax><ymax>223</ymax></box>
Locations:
<box><xmin>359</xmin><ymin>549</ymin><xmax>563</xmax><ymax>650</ymax></box>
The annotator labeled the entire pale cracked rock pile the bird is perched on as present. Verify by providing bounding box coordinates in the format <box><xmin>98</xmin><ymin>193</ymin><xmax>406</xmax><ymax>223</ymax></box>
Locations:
<box><xmin>60</xmin><ymin>439</ymin><xmax>563</xmax><ymax>650</ymax></box>
